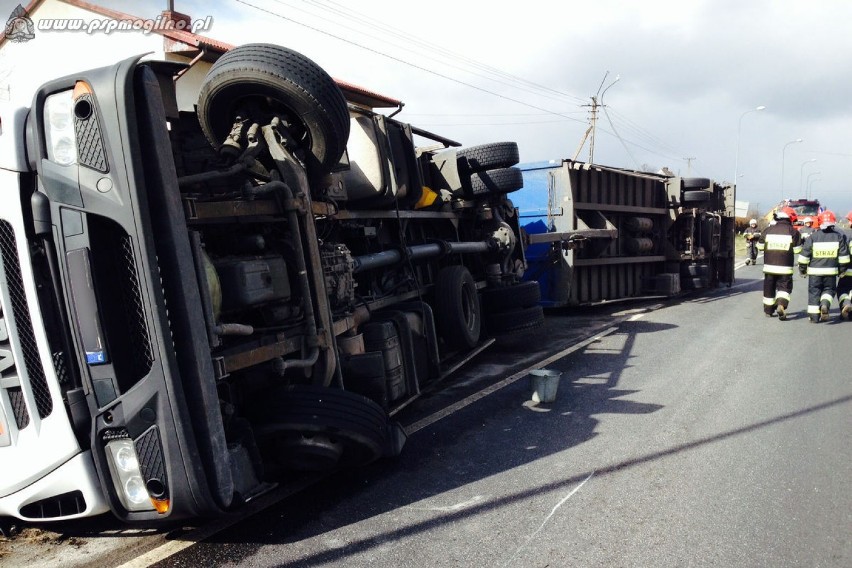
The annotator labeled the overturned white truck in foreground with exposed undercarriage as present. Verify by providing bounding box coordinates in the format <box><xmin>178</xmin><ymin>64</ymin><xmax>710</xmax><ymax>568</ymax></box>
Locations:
<box><xmin>0</xmin><ymin>44</ymin><xmax>543</xmax><ymax>522</ymax></box>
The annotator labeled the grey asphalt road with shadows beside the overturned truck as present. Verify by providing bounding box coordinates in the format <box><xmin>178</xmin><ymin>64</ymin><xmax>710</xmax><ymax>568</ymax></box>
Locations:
<box><xmin>0</xmin><ymin>265</ymin><xmax>852</xmax><ymax>568</ymax></box>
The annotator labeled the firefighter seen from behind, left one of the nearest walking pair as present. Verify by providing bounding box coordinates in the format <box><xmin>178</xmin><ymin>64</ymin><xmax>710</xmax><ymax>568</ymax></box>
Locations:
<box><xmin>757</xmin><ymin>207</ymin><xmax>802</xmax><ymax>321</ymax></box>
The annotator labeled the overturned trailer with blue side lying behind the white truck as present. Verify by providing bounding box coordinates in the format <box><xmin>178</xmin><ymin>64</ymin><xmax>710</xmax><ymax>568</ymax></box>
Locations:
<box><xmin>514</xmin><ymin>160</ymin><xmax>736</xmax><ymax>307</ymax></box>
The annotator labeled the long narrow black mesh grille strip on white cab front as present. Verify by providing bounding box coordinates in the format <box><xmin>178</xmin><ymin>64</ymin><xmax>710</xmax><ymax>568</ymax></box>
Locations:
<box><xmin>0</xmin><ymin>220</ymin><xmax>53</xmax><ymax>420</ymax></box>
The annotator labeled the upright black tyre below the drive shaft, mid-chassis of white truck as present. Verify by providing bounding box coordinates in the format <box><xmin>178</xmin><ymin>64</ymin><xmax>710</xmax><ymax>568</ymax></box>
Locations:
<box><xmin>435</xmin><ymin>266</ymin><xmax>482</xmax><ymax>349</ymax></box>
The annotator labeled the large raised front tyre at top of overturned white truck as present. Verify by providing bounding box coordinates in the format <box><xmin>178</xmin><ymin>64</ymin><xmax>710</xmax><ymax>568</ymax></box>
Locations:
<box><xmin>198</xmin><ymin>43</ymin><xmax>349</xmax><ymax>171</ymax></box>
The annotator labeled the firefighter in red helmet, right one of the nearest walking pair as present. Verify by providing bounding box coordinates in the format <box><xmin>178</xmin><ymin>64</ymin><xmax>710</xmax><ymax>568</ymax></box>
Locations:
<box><xmin>799</xmin><ymin>210</ymin><xmax>850</xmax><ymax>323</ymax></box>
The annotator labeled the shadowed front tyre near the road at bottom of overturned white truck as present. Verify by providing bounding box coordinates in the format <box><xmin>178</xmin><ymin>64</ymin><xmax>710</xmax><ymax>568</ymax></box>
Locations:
<box><xmin>253</xmin><ymin>385</ymin><xmax>388</xmax><ymax>472</ymax></box>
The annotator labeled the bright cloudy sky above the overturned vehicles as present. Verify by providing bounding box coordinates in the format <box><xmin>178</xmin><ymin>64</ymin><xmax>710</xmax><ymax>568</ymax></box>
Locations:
<box><xmin>0</xmin><ymin>0</ymin><xmax>852</xmax><ymax>217</ymax></box>
